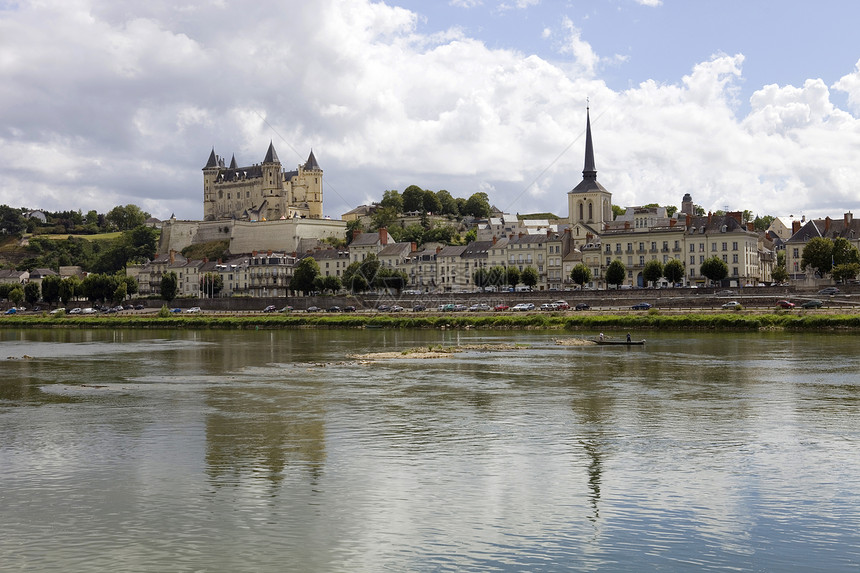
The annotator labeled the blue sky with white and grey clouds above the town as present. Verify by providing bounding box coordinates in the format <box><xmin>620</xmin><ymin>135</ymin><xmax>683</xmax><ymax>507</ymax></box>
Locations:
<box><xmin>0</xmin><ymin>0</ymin><xmax>860</xmax><ymax>223</ymax></box>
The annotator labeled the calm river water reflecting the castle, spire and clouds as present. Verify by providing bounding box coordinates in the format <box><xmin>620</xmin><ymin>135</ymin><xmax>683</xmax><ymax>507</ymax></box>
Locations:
<box><xmin>0</xmin><ymin>329</ymin><xmax>860</xmax><ymax>572</ymax></box>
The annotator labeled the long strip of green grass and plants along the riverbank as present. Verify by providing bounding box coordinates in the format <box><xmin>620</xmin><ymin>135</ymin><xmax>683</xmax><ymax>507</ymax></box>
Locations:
<box><xmin>0</xmin><ymin>312</ymin><xmax>860</xmax><ymax>331</ymax></box>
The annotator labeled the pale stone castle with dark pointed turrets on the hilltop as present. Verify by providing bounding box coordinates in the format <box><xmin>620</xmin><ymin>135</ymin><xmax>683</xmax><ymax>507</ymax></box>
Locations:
<box><xmin>203</xmin><ymin>142</ymin><xmax>322</xmax><ymax>221</ymax></box>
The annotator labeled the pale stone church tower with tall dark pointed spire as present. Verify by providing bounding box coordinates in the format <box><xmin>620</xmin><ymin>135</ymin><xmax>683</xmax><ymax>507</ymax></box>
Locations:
<box><xmin>567</xmin><ymin>108</ymin><xmax>612</xmax><ymax>234</ymax></box>
